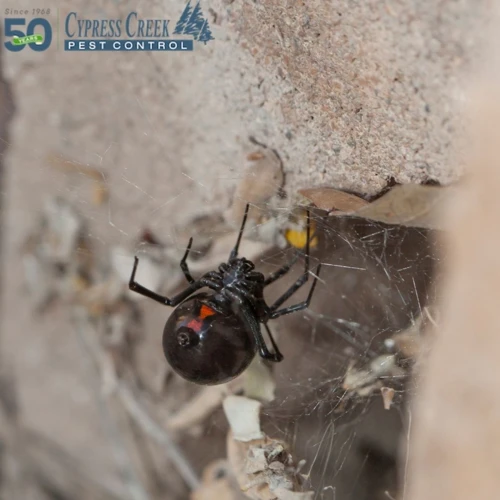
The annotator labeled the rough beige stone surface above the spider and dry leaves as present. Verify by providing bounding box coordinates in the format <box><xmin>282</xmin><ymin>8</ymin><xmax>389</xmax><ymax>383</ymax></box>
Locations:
<box><xmin>1</xmin><ymin>0</ymin><xmax>489</xmax><ymax>236</ymax></box>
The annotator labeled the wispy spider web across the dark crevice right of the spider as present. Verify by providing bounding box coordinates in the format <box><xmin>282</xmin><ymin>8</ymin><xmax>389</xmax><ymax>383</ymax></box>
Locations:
<box><xmin>258</xmin><ymin>219</ymin><xmax>434</xmax><ymax>498</ymax></box>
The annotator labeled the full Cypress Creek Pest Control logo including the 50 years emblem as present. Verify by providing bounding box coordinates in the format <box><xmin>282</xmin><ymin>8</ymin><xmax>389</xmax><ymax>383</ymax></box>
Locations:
<box><xmin>4</xmin><ymin>0</ymin><xmax>214</xmax><ymax>52</ymax></box>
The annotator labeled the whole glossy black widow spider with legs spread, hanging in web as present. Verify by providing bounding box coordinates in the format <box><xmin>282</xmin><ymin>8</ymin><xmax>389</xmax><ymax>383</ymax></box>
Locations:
<box><xmin>129</xmin><ymin>204</ymin><xmax>321</xmax><ymax>385</ymax></box>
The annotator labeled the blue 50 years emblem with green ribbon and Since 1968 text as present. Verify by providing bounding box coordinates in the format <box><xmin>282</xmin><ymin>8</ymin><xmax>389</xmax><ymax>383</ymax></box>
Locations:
<box><xmin>4</xmin><ymin>9</ymin><xmax>52</xmax><ymax>52</ymax></box>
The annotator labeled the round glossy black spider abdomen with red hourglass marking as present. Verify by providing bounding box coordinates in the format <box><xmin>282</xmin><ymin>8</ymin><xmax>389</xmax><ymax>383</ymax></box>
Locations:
<box><xmin>163</xmin><ymin>294</ymin><xmax>257</xmax><ymax>385</ymax></box>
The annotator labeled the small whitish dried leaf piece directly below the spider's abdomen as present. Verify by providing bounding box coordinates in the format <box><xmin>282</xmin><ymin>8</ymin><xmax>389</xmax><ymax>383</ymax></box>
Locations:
<box><xmin>222</xmin><ymin>396</ymin><xmax>263</xmax><ymax>442</ymax></box>
